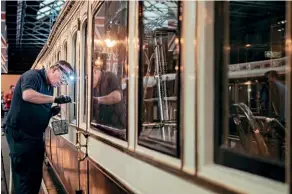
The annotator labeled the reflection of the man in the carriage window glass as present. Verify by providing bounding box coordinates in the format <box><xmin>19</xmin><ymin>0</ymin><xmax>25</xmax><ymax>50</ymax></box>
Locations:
<box><xmin>93</xmin><ymin>54</ymin><xmax>126</xmax><ymax>129</ymax></box>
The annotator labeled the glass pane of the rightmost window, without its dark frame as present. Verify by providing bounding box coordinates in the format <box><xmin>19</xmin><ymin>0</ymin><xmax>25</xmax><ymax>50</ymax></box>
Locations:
<box><xmin>215</xmin><ymin>1</ymin><xmax>288</xmax><ymax>179</ymax></box>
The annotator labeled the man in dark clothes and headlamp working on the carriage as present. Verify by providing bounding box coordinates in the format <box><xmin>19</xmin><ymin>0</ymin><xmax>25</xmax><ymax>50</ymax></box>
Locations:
<box><xmin>5</xmin><ymin>61</ymin><xmax>73</xmax><ymax>194</ymax></box>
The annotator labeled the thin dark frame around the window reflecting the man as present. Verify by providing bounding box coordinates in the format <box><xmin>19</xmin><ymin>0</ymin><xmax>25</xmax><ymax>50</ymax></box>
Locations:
<box><xmin>88</xmin><ymin>1</ymin><xmax>130</xmax><ymax>142</ymax></box>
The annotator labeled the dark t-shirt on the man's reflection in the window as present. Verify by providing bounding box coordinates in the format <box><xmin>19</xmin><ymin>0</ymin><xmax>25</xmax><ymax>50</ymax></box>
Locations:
<box><xmin>93</xmin><ymin>72</ymin><xmax>126</xmax><ymax>129</ymax></box>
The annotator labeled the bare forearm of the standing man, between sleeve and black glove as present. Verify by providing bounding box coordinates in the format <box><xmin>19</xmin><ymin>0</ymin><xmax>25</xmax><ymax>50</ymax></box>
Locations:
<box><xmin>22</xmin><ymin>89</ymin><xmax>55</xmax><ymax>104</ymax></box>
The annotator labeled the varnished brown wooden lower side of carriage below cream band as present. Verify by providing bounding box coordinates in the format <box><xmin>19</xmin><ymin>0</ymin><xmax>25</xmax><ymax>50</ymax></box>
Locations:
<box><xmin>46</xmin><ymin>129</ymin><xmax>132</xmax><ymax>194</ymax></box>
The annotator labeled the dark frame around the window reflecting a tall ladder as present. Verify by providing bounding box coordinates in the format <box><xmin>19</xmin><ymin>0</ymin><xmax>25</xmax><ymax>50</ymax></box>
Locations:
<box><xmin>137</xmin><ymin>1</ymin><xmax>183</xmax><ymax>158</ymax></box>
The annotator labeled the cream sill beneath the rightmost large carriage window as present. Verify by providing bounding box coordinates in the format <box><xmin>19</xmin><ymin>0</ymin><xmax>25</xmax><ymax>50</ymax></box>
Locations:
<box><xmin>198</xmin><ymin>164</ymin><xmax>289</xmax><ymax>194</ymax></box>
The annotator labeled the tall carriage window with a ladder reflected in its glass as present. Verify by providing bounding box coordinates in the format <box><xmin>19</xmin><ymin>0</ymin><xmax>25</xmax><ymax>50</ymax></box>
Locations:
<box><xmin>139</xmin><ymin>1</ymin><xmax>180</xmax><ymax>157</ymax></box>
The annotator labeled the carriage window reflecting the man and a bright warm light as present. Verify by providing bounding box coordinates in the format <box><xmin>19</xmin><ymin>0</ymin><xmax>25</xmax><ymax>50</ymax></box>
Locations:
<box><xmin>91</xmin><ymin>1</ymin><xmax>128</xmax><ymax>139</ymax></box>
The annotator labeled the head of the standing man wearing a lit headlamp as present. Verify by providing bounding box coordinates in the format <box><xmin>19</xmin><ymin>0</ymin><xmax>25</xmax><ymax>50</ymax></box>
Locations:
<box><xmin>47</xmin><ymin>61</ymin><xmax>74</xmax><ymax>87</ymax></box>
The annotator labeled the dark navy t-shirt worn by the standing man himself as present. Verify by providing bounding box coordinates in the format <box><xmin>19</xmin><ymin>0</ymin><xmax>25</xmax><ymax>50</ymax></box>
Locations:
<box><xmin>6</xmin><ymin>69</ymin><xmax>53</xmax><ymax>138</ymax></box>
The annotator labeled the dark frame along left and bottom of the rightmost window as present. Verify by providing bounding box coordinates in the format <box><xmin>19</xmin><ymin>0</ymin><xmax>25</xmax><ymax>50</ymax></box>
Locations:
<box><xmin>213</xmin><ymin>2</ymin><xmax>288</xmax><ymax>182</ymax></box>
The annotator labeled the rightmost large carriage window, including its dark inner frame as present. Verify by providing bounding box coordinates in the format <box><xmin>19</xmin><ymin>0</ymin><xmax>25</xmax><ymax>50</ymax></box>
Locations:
<box><xmin>214</xmin><ymin>1</ymin><xmax>290</xmax><ymax>181</ymax></box>
